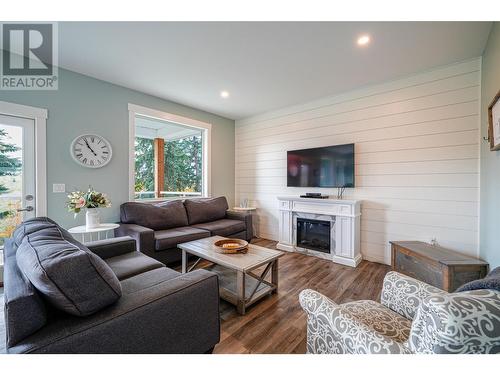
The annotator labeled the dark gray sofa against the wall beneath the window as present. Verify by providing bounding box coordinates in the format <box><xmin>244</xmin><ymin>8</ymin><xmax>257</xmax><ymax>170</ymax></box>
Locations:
<box><xmin>115</xmin><ymin>197</ymin><xmax>253</xmax><ymax>264</ymax></box>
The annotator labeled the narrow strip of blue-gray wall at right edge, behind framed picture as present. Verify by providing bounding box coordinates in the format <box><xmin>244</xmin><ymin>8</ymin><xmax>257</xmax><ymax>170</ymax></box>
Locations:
<box><xmin>479</xmin><ymin>22</ymin><xmax>500</xmax><ymax>268</ymax></box>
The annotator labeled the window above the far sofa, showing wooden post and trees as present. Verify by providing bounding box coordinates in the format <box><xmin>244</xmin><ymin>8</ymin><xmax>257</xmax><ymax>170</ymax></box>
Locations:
<box><xmin>131</xmin><ymin>104</ymin><xmax>210</xmax><ymax>199</ymax></box>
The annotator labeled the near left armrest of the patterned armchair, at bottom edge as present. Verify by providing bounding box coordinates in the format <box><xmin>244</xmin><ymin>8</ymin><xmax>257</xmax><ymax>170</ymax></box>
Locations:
<box><xmin>299</xmin><ymin>289</ymin><xmax>410</xmax><ymax>354</ymax></box>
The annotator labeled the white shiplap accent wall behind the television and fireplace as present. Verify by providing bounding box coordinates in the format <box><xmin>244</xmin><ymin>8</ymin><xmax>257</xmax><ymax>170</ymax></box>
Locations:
<box><xmin>235</xmin><ymin>58</ymin><xmax>481</xmax><ymax>264</ymax></box>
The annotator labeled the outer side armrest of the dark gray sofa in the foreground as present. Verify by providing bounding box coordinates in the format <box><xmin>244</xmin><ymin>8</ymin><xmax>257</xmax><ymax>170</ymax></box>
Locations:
<box><xmin>9</xmin><ymin>270</ymin><xmax>220</xmax><ymax>354</ymax></box>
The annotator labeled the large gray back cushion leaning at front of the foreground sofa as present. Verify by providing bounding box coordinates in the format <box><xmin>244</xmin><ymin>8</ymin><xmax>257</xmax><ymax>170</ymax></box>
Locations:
<box><xmin>16</xmin><ymin>224</ymin><xmax>121</xmax><ymax>316</ymax></box>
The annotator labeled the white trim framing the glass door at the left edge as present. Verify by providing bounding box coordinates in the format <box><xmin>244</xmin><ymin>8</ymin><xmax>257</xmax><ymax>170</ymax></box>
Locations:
<box><xmin>0</xmin><ymin>101</ymin><xmax>48</xmax><ymax>216</ymax></box>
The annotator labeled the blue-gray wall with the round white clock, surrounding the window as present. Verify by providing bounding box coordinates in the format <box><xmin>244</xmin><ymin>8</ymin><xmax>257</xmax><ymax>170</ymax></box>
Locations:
<box><xmin>0</xmin><ymin>69</ymin><xmax>234</xmax><ymax>231</ymax></box>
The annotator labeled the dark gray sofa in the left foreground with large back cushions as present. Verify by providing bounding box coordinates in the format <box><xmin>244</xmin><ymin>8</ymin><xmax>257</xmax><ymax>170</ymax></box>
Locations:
<box><xmin>4</xmin><ymin>218</ymin><xmax>220</xmax><ymax>353</ymax></box>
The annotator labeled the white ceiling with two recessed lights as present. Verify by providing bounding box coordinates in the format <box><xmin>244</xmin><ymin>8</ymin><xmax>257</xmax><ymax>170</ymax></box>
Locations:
<box><xmin>59</xmin><ymin>22</ymin><xmax>491</xmax><ymax>119</ymax></box>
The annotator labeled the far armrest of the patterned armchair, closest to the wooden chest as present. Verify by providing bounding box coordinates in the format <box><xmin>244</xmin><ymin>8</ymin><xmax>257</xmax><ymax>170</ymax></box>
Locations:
<box><xmin>380</xmin><ymin>271</ymin><xmax>447</xmax><ymax>320</ymax></box>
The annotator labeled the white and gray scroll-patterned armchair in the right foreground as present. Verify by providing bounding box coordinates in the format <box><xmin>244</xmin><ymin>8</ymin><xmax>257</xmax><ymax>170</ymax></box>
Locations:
<box><xmin>300</xmin><ymin>272</ymin><xmax>500</xmax><ymax>354</ymax></box>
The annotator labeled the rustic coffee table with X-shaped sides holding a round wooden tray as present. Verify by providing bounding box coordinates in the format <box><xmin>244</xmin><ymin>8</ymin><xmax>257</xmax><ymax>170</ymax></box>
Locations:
<box><xmin>177</xmin><ymin>236</ymin><xmax>284</xmax><ymax>315</ymax></box>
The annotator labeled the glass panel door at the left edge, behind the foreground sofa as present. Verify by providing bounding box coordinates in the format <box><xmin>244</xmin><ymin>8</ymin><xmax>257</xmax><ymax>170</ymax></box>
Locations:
<box><xmin>0</xmin><ymin>115</ymin><xmax>36</xmax><ymax>249</ymax></box>
